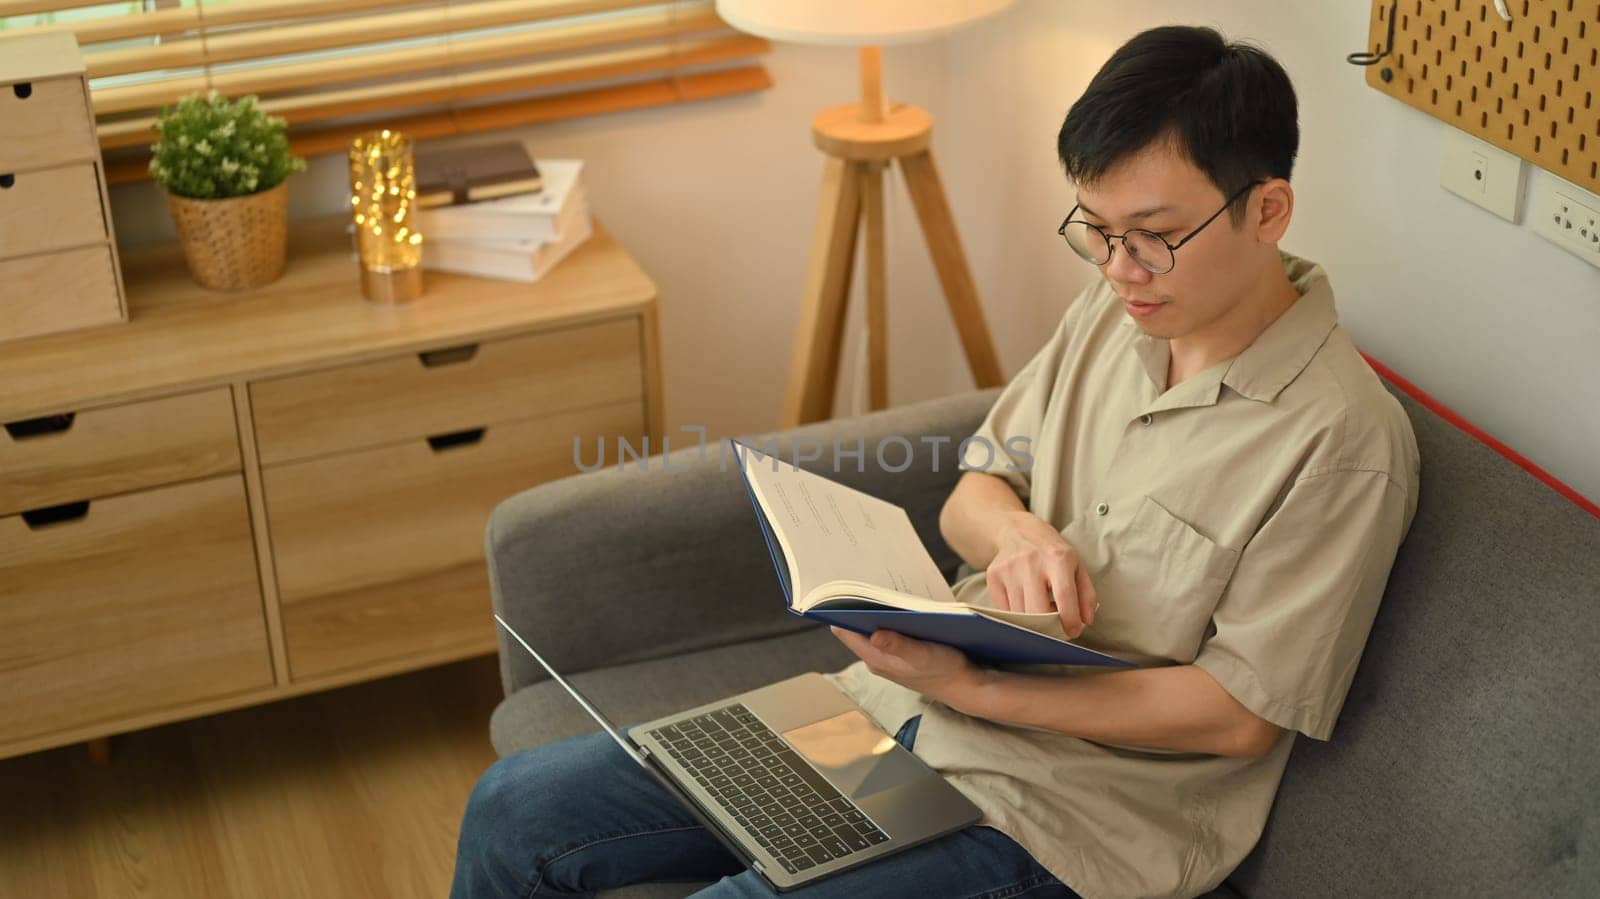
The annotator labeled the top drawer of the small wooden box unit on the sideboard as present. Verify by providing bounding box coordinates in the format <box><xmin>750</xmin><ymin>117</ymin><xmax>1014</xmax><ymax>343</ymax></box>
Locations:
<box><xmin>0</xmin><ymin>75</ymin><xmax>99</xmax><ymax>174</ymax></box>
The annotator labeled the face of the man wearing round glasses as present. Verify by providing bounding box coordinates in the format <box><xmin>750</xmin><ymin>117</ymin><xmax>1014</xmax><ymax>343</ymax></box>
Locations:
<box><xmin>1075</xmin><ymin>141</ymin><xmax>1262</xmax><ymax>339</ymax></box>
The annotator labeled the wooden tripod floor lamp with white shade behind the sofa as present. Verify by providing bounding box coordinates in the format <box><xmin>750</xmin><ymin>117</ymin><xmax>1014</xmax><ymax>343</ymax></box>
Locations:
<box><xmin>717</xmin><ymin>0</ymin><xmax>1011</xmax><ymax>427</ymax></box>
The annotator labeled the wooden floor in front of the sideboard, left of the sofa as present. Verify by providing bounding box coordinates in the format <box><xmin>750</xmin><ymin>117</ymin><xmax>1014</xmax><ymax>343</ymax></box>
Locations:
<box><xmin>0</xmin><ymin>657</ymin><xmax>501</xmax><ymax>899</ymax></box>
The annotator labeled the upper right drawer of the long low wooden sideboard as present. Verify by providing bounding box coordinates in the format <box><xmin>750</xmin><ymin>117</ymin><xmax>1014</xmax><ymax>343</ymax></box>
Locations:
<box><xmin>250</xmin><ymin>318</ymin><xmax>643</xmax><ymax>465</ymax></box>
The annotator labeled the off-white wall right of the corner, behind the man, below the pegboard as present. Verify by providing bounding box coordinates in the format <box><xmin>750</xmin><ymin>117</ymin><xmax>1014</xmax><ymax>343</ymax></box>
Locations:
<box><xmin>942</xmin><ymin>0</ymin><xmax>1600</xmax><ymax>499</ymax></box>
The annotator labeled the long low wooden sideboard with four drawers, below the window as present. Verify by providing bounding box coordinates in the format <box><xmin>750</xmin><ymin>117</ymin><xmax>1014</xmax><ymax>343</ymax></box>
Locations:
<box><xmin>0</xmin><ymin>221</ymin><xmax>661</xmax><ymax>757</ymax></box>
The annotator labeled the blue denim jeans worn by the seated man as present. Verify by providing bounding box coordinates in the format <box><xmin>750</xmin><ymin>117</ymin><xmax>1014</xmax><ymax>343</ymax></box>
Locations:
<box><xmin>450</xmin><ymin>717</ymin><xmax>1077</xmax><ymax>899</ymax></box>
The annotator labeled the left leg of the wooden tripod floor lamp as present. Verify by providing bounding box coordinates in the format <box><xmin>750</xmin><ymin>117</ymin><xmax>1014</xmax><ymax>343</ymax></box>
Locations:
<box><xmin>781</xmin><ymin>157</ymin><xmax>861</xmax><ymax>427</ymax></box>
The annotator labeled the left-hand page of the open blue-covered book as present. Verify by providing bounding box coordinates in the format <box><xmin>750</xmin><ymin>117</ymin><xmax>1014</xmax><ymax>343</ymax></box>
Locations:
<box><xmin>736</xmin><ymin>445</ymin><xmax>955</xmax><ymax>611</ymax></box>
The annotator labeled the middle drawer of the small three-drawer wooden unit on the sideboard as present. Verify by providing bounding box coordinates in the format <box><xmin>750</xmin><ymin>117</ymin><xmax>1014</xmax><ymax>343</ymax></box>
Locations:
<box><xmin>0</xmin><ymin>162</ymin><xmax>106</xmax><ymax>259</ymax></box>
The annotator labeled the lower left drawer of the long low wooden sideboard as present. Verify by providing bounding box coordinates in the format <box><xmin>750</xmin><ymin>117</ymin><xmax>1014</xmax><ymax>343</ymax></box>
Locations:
<box><xmin>0</xmin><ymin>475</ymin><xmax>272</xmax><ymax>744</ymax></box>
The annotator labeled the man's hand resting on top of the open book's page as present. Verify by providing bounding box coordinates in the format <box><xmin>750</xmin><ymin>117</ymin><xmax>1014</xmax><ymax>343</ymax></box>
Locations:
<box><xmin>986</xmin><ymin>512</ymin><xmax>1099</xmax><ymax>638</ymax></box>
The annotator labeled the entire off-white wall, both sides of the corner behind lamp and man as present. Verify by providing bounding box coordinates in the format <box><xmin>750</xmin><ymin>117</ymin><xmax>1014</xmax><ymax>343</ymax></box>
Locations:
<box><xmin>112</xmin><ymin>0</ymin><xmax>1600</xmax><ymax>497</ymax></box>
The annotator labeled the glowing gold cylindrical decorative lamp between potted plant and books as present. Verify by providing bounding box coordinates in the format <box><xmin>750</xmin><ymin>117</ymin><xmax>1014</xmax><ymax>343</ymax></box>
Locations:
<box><xmin>350</xmin><ymin>128</ymin><xmax>422</xmax><ymax>302</ymax></box>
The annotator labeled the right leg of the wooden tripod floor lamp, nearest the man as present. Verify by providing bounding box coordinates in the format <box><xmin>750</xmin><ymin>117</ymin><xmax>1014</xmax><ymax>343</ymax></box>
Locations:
<box><xmin>899</xmin><ymin>150</ymin><xmax>1005</xmax><ymax>387</ymax></box>
